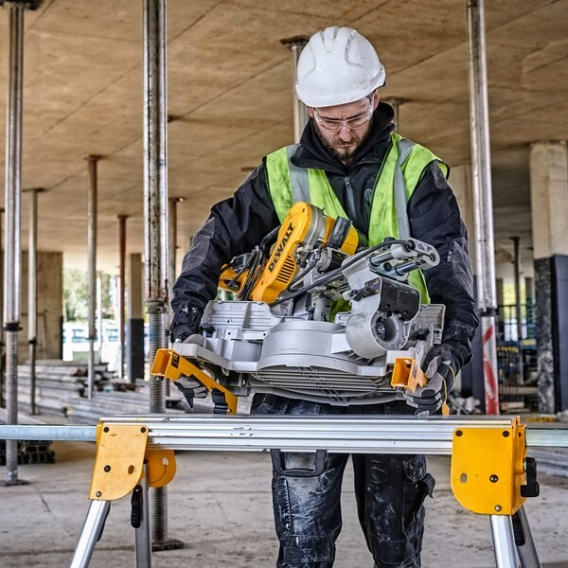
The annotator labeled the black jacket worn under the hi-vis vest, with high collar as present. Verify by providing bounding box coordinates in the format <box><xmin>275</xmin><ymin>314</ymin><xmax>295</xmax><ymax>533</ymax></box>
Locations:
<box><xmin>172</xmin><ymin>103</ymin><xmax>478</xmax><ymax>363</ymax></box>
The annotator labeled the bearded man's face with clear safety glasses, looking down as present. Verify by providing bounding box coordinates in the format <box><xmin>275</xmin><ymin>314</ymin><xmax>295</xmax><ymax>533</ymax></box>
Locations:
<box><xmin>308</xmin><ymin>91</ymin><xmax>379</xmax><ymax>165</ymax></box>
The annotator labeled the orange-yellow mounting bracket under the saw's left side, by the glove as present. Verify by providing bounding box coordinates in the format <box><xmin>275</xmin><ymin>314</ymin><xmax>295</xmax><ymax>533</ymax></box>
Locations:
<box><xmin>151</xmin><ymin>349</ymin><xmax>237</xmax><ymax>414</ymax></box>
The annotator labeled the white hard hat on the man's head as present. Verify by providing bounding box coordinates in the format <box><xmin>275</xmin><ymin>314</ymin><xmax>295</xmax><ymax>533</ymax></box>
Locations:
<box><xmin>296</xmin><ymin>26</ymin><xmax>386</xmax><ymax>108</ymax></box>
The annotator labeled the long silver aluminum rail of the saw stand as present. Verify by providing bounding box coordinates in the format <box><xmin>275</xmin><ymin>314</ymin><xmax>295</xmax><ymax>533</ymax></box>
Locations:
<box><xmin>0</xmin><ymin>415</ymin><xmax>568</xmax><ymax>455</ymax></box>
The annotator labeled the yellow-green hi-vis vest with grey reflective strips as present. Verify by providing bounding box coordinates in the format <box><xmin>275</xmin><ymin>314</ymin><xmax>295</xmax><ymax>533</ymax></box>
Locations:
<box><xmin>266</xmin><ymin>133</ymin><xmax>448</xmax><ymax>304</ymax></box>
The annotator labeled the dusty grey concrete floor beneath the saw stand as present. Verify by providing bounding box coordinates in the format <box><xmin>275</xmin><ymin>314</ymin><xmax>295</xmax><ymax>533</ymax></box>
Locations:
<box><xmin>0</xmin><ymin>442</ymin><xmax>568</xmax><ymax>568</ymax></box>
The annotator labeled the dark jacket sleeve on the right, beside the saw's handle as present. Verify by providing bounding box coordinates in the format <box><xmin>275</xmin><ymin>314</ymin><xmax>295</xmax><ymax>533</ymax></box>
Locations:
<box><xmin>407</xmin><ymin>162</ymin><xmax>479</xmax><ymax>363</ymax></box>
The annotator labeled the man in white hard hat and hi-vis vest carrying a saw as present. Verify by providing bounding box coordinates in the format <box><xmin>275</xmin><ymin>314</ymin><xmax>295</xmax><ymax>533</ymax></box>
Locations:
<box><xmin>171</xmin><ymin>27</ymin><xmax>478</xmax><ymax>568</ymax></box>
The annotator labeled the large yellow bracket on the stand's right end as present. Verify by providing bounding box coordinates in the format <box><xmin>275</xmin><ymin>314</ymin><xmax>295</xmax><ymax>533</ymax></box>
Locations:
<box><xmin>451</xmin><ymin>416</ymin><xmax>528</xmax><ymax>515</ymax></box>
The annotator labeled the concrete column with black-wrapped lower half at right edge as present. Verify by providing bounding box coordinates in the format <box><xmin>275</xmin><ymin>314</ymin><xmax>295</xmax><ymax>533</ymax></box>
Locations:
<box><xmin>530</xmin><ymin>142</ymin><xmax>568</xmax><ymax>413</ymax></box>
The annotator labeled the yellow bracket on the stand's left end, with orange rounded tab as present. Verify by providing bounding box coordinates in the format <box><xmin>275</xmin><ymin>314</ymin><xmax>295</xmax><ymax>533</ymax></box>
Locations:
<box><xmin>89</xmin><ymin>423</ymin><xmax>176</xmax><ymax>501</ymax></box>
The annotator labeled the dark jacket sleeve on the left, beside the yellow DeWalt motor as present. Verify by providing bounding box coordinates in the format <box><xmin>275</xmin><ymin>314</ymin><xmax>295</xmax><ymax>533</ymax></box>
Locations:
<box><xmin>171</xmin><ymin>164</ymin><xmax>279</xmax><ymax>339</ymax></box>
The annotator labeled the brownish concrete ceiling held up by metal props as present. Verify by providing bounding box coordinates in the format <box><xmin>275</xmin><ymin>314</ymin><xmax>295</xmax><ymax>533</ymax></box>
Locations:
<box><xmin>0</xmin><ymin>0</ymin><xmax>568</xmax><ymax>273</ymax></box>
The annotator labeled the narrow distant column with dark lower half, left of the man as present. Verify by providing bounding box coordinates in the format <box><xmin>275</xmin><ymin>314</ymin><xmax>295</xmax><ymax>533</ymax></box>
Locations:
<box><xmin>126</xmin><ymin>253</ymin><xmax>144</xmax><ymax>383</ymax></box>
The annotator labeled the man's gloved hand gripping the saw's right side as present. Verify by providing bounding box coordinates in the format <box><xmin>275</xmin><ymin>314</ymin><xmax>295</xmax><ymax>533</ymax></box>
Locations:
<box><xmin>404</xmin><ymin>341</ymin><xmax>463</xmax><ymax>416</ymax></box>
